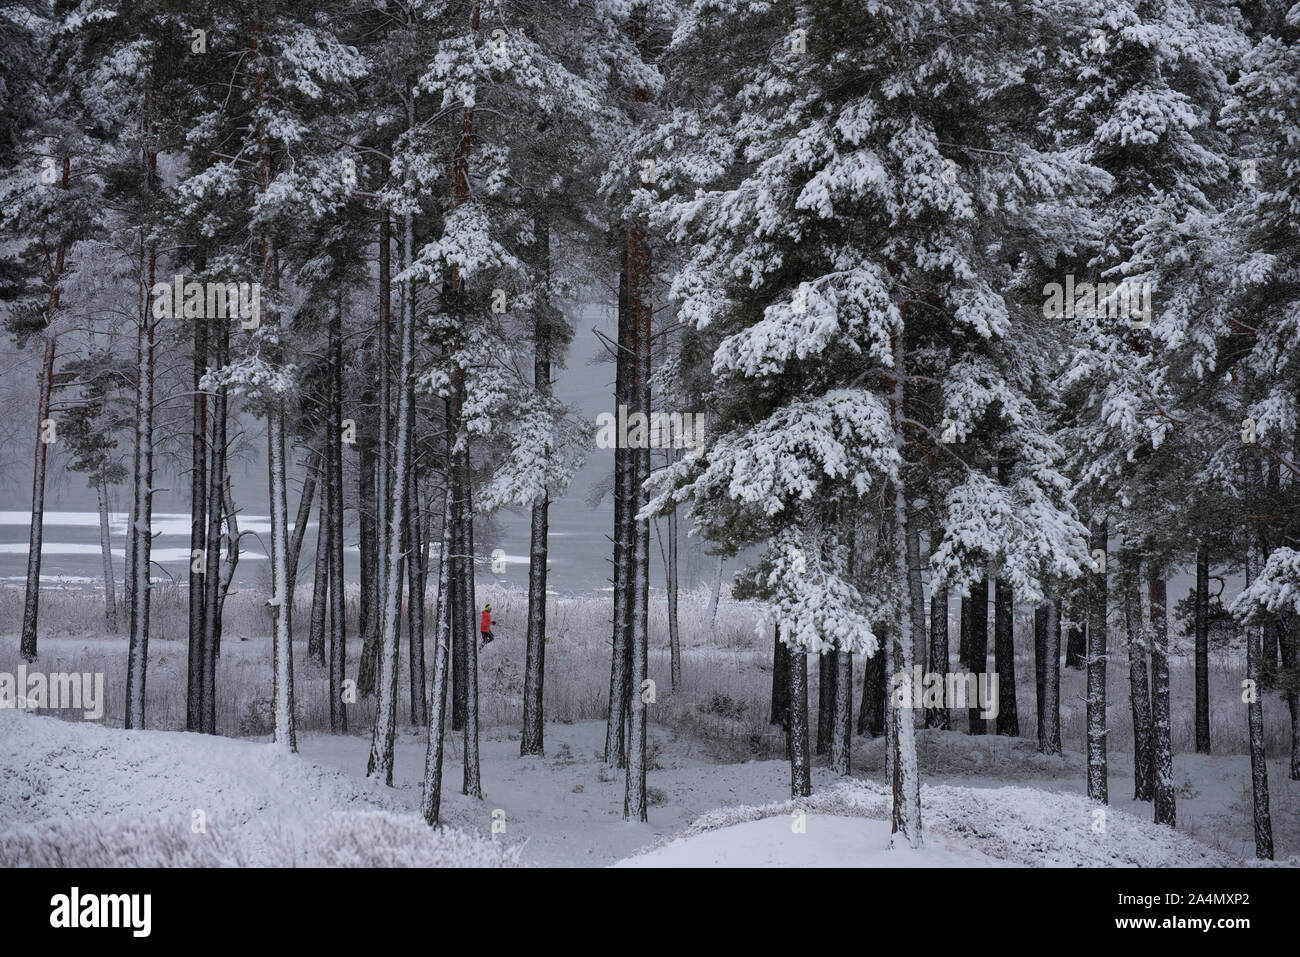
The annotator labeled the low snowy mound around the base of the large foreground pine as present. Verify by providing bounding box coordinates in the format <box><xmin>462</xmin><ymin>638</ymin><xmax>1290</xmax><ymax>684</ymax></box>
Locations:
<box><xmin>620</xmin><ymin>781</ymin><xmax>1236</xmax><ymax>867</ymax></box>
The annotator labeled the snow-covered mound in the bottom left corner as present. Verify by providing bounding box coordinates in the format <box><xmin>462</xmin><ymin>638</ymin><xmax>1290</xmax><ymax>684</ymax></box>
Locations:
<box><xmin>0</xmin><ymin>709</ymin><xmax>517</xmax><ymax>867</ymax></box>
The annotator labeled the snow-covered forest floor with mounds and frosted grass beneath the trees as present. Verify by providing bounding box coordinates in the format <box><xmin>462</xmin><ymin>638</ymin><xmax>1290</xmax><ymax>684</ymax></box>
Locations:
<box><xmin>0</xmin><ymin>588</ymin><xmax>1300</xmax><ymax>866</ymax></box>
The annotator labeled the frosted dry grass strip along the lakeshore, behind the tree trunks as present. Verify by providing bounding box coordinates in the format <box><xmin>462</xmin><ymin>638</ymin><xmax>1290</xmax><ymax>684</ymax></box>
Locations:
<box><xmin>0</xmin><ymin>584</ymin><xmax>1291</xmax><ymax>761</ymax></box>
